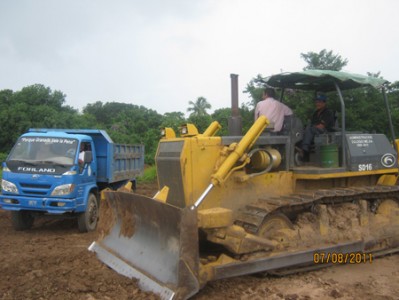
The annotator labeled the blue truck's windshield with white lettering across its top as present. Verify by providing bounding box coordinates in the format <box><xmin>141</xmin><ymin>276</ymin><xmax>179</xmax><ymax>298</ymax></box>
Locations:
<box><xmin>7</xmin><ymin>136</ymin><xmax>78</xmax><ymax>165</ymax></box>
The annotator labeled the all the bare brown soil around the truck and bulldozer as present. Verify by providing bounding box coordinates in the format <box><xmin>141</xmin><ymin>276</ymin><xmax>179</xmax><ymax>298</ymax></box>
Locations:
<box><xmin>0</xmin><ymin>184</ymin><xmax>399</xmax><ymax>300</ymax></box>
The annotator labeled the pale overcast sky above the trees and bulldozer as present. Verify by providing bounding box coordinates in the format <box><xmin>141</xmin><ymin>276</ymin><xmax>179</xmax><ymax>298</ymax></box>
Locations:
<box><xmin>0</xmin><ymin>0</ymin><xmax>399</xmax><ymax>114</ymax></box>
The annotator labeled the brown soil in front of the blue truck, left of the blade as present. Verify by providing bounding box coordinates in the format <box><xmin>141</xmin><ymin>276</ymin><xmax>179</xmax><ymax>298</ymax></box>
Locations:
<box><xmin>0</xmin><ymin>212</ymin><xmax>156</xmax><ymax>299</ymax></box>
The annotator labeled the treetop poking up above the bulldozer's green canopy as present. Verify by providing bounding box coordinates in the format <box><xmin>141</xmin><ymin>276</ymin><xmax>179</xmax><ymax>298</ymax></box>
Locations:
<box><xmin>301</xmin><ymin>49</ymin><xmax>348</xmax><ymax>71</ymax></box>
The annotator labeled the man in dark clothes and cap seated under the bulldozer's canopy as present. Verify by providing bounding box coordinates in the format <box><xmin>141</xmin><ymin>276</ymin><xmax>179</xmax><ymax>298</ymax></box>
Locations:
<box><xmin>302</xmin><ymin>94</ymin><xmax>335</xmax><ymax>160</ymax></box>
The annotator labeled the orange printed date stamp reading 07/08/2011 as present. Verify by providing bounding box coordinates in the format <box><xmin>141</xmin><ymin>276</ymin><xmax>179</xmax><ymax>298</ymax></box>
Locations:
<box><xmin>313</xmin><ymin>252</ymin><xmax>373</xmax><ymax>264</ymax></box>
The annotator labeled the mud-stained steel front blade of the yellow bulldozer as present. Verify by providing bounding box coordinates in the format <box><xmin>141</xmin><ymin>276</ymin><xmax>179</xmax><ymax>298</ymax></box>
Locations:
<box><xmin>89</xmin><ymin>191</ymin><xmax>199</xmax><ymax>299</ymax></box>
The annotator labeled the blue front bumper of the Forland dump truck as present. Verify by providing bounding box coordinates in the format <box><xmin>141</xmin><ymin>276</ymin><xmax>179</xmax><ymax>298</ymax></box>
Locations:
<box><xmin>0</xmin><ymin>194</ymin><xmax>84</xmax><ymax>214</ymax></box>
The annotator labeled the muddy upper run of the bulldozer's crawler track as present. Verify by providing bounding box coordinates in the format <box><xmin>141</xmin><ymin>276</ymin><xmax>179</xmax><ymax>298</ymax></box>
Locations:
<box><xmin>235</xmin><ymin>185</ymin><xmax>399</xmax><ymax>234</ymax></box>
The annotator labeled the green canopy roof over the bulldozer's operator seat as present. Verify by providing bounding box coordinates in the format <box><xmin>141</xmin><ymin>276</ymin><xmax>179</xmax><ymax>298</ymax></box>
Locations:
<box><xmin>263</xmin><ymin>70</ymin><xmax>388</xmax><ymax>92</ymax></box>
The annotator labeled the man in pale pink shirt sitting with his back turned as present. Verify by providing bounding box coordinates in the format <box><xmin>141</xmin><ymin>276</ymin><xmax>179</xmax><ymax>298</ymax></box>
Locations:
<box><xmin>255</xmin><ymin>88</ymin><xmax>292</xmax><ymax>132</ymax></box>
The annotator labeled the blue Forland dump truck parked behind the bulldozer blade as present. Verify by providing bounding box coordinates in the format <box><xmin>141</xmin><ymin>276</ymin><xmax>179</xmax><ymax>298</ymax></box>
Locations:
<box><xmin>0</xmin><ymin>129</ymin><xmax>144</xmax><ymax>232</ymax></box>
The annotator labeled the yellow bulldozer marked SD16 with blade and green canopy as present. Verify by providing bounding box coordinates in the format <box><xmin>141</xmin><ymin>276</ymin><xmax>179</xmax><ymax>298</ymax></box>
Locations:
<box><xmin>89</xmin><ymin>70</ymin><xmax>399</xmax><ymax>299</ymax></box>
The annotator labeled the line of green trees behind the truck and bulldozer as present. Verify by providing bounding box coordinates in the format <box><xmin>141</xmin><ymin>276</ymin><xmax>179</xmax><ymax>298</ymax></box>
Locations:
<box><xmin>0</xmin><ymin>49</ymin><xmax>399</xmax><ymax>164</ymax></box>
